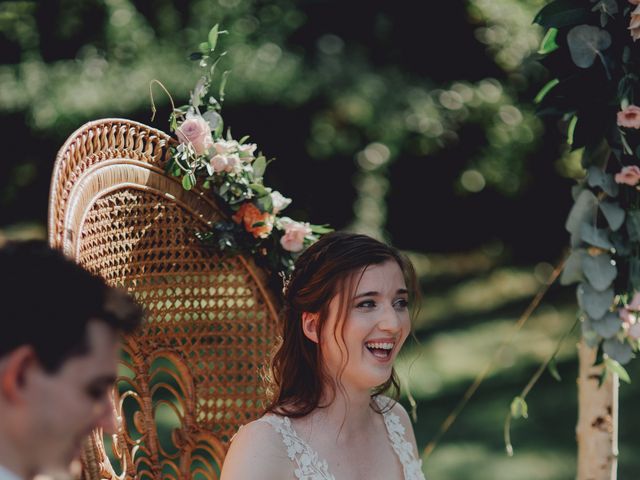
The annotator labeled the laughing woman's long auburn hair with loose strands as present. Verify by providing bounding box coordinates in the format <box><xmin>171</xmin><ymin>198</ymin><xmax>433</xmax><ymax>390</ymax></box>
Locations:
<box><xmin>265</xmin><ymin>232</ymin><xmax>419</xmax><ymax>418</ymax></box>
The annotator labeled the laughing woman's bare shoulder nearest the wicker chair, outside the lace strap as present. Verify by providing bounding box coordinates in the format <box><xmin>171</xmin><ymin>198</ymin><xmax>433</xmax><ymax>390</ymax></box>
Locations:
<box><xmin>220</xmin><ymin>420</ymin><xmax>293</xmax><ymax>480</ymax></box>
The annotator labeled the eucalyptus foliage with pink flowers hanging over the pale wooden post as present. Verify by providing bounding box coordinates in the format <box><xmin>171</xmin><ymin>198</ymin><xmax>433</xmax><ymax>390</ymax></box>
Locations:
<box><xmin>535</xmin><ymin>0</ymin><xmax>640</xmax><ymax>372</ymax></box>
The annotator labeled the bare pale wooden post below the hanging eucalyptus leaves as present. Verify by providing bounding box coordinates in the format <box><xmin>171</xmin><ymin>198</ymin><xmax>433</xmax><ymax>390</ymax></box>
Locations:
<box><xmin>576</xmin><ymin>340</ymin><xmax>618</xmax><ymax>480</ymax></box>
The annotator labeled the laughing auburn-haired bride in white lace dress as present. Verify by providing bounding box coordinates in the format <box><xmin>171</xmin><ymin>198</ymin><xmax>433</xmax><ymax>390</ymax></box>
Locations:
<box><xmin>221</xmin><ymin>233</ymin><xmax>424</xmax><ymax>480</ymax></box>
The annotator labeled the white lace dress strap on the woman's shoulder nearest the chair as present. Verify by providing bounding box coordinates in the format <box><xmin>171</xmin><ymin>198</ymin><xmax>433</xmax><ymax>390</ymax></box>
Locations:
<box><xmin>257</xmin><ymin>415</ymin><xmax>335</xmax><ymax>480</ymax></box>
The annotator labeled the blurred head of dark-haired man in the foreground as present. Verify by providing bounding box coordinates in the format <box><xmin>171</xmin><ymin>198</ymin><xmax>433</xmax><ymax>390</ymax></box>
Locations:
<box><xmin>0</xmin><ymin>241</ymin><xmax>142</xmax><ymax>476</ymax></box>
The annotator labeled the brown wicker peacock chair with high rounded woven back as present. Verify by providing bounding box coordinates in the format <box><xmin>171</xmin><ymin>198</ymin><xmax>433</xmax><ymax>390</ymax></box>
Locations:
<box><xmin>49</xmin><ymin>119</ymin><xmax>277</xmax><ymax>480</ymax></box>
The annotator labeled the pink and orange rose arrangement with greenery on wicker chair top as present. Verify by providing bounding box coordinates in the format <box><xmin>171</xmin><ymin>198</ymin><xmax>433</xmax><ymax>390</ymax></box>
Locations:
<box><xmin>150</xmin><ymin>25</ymin><xmax>331</xmax><ymax>276</ymax></box>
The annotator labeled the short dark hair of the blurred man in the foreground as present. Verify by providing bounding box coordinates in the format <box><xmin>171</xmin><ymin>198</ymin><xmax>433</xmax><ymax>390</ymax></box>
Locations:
<box><xmin>0</xmin><ymin>240</ymin><xmax>142</xmax><ymax>373</ymax></box>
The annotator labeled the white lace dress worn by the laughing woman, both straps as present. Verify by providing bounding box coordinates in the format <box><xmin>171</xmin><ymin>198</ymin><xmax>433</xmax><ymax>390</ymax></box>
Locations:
<box><xmin>258</xmin><ymin>402</ymin><xmax>425</xmax><ymax>480</ymax></box>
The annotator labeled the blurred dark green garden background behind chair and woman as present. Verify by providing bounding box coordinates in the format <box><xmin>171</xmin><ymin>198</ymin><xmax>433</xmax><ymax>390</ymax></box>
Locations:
<box><xmin>0</xmin><ymin>0</ymin><xmax>640</xmax><ymax>480</ymax></box>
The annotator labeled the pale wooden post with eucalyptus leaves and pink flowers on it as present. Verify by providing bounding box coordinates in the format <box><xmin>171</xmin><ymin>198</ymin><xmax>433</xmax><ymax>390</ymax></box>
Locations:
<box><xmin>535</xmin><ymin>0</ymin><xmax>640</xmax><ymax>480</ymax></box>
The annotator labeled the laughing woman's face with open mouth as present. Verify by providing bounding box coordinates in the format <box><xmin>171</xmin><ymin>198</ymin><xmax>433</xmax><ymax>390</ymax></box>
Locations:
<box><xmin>321</xmin><ymin>260</ymin><xmax>411</xmax><ymax>390</ymax></box>
